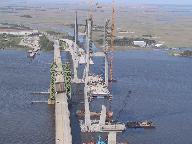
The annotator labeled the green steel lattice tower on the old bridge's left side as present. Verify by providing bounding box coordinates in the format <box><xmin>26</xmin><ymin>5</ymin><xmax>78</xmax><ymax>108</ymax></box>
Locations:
<box><xmin>49</xmin><ymin>62</ymin><xmax>55</xmax><ymax>100</ymax></box>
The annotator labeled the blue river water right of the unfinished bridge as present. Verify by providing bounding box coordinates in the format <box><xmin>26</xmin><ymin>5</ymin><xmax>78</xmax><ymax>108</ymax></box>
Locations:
<box><xmin>113</xmin><ymin>51</ymin><xmax>192</xmax><ymax>144</ymax></box>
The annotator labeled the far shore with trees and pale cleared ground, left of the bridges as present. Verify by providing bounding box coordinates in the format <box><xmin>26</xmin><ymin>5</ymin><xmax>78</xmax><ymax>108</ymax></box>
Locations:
<box><xmin>0</xmin><ymin>26</ymin><xmax>53</xmax><ymax>52</ymax></box>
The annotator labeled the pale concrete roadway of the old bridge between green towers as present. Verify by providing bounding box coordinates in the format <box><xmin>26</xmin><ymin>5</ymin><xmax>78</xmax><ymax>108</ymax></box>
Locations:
<box><xmin>54</xmin><ymin>40</ymin><xmax>72</xmax><ymax>144</ymax></box>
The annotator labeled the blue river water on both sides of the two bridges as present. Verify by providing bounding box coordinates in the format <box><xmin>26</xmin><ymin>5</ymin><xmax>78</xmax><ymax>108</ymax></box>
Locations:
<box><xmin>0</xmin><ymin>50</ymin><xmax>192</xmax><ymax>144</ymax></box>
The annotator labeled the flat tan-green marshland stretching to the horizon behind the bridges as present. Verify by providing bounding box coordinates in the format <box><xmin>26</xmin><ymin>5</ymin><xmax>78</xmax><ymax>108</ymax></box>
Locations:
<box><xmin>0</xmin><ymin>5</ymin><xmax>192</xmax><ymax>48</ymax></box>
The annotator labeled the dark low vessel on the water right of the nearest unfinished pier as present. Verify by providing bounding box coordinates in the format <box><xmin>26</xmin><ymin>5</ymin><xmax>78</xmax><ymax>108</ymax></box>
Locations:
<box><xmin>126</xmin><ymin>120</ymin><xmax>155</xmax><ymax>129</ymax></box>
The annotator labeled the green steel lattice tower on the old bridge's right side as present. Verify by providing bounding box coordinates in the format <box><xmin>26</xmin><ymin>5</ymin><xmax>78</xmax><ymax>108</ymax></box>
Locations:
<box><xmin>63</xmin><ymin>62</ymin><xmax>71</xmax><ymax>98</ymax></box>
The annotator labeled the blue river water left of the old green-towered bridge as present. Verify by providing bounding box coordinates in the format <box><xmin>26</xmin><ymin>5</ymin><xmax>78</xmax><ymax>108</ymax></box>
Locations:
<box><xmin>0</xmin><ymin>50</ymin><xmax>55</xmax><ymax>144</ymax></box>
